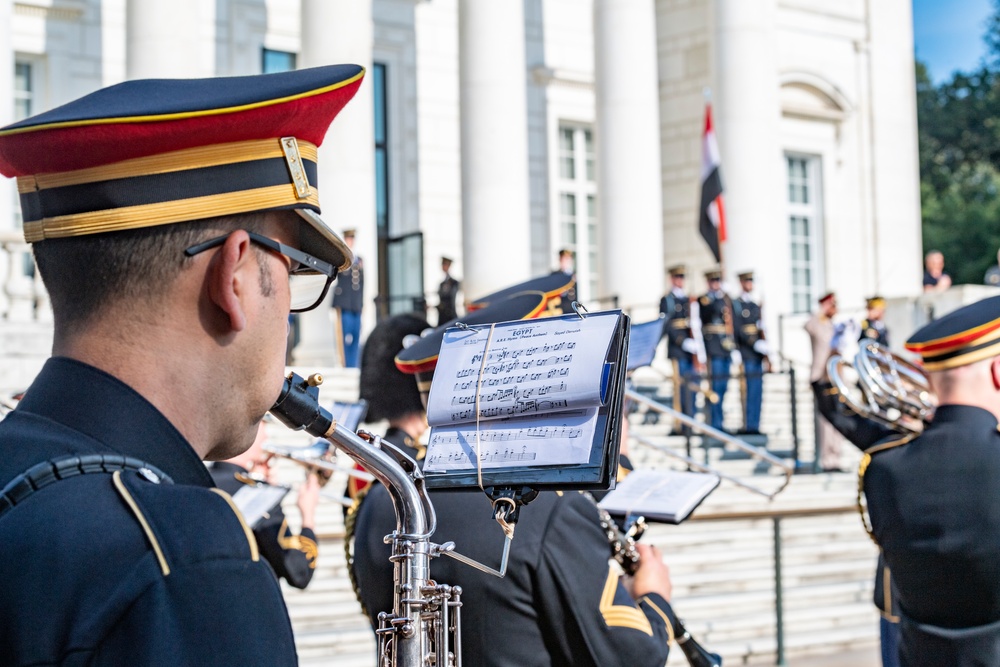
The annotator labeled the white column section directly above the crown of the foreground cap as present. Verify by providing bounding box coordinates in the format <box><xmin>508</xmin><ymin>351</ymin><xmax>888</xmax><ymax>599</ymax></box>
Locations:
<box><xmin>125</xmin><ymin>0</ymin><xmax>216</xmax><ymax>79</ymax></box>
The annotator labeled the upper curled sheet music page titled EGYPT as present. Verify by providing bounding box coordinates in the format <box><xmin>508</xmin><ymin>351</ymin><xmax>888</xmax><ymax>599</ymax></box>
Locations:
<box><xmin>427</xmin><ymin>313</ymin><xmax>620</xmax><ymax>426</ymax></box>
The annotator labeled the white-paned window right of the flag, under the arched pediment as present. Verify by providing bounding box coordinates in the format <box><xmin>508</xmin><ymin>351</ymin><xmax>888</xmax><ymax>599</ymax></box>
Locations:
<box><xmin>785</xmin><ymin>155</ymin><xmax>822</xmax><ymax>313</ymax></box>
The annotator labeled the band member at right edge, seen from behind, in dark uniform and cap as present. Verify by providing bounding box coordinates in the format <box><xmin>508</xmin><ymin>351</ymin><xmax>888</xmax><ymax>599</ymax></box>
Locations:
<box><xmin>816</xmin><ymin>297</ymin><xmax>1000</xmax><ymax>665</ymax></box>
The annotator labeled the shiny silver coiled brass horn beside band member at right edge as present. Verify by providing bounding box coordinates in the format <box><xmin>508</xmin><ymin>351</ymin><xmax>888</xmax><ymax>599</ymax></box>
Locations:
<box><xmin>827</xmin><ymin>342</ymin><xmax>937</xmax><ymax>433</ymax></box>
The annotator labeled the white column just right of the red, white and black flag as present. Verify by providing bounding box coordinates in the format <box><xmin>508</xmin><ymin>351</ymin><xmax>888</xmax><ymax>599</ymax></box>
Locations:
<box><xmin>716</xmin><ymin>0</ymin><xmax>791</xmax><ymax>312</ymax></box>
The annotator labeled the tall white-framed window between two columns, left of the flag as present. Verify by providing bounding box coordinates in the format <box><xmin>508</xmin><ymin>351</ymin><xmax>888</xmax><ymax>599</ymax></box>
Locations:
<box><xmin>558</xmin><ymin>125</ymin><xmax>600</xmax><ymax>301</ymax></box>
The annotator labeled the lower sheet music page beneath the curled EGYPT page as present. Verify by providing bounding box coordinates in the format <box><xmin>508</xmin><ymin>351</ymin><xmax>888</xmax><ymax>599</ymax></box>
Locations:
<box><xmin>424</xmin><ymin>408</ymin><xmax>597</xmax><ymax>472</ymax></box>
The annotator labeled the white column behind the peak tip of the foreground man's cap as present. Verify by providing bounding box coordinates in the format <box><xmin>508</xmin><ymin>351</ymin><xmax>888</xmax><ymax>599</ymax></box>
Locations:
<box><xmin>293</xmin><ymin>0</ymin><xmax>378</xmax><ymax>365</ymax></box>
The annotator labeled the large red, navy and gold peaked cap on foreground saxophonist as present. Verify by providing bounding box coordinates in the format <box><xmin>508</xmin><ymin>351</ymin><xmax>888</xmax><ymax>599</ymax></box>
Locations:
<box><xmin>0</xmin><ymin>65</ymin><xmax>364</xmax><ymax>269</ymax></box>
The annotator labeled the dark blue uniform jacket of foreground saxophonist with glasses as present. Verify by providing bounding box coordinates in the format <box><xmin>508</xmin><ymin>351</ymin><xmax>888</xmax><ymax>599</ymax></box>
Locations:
<box><xmin>0</xmin><ymin>358</ymin><xmax>296</xmax><ymax>665</ymax></box>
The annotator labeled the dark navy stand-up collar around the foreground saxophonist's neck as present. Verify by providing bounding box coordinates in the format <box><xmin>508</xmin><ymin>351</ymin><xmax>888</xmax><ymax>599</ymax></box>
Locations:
<box><xmin>17</xmin><ymin>357</ymin><xmax>214</xmax><ymax>487</ymax></box>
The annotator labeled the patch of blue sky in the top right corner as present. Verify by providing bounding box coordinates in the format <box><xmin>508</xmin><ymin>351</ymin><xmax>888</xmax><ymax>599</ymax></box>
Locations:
<box><xmin>916</xmin><ymin>0</ymin><xmax>993</xmax><ymax>83</ymax></box>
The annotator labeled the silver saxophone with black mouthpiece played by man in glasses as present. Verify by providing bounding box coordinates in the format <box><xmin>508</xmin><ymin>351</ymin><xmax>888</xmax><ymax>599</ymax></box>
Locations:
<box><xmin>271</xmin><ymin>373</ymin><xmax>462</xmax><ymax>667</ymax></box>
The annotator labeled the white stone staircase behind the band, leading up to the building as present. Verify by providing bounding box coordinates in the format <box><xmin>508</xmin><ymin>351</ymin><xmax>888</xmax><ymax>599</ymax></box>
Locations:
<box><xmin>269</xmin><ymin>370</ymin><xmax>878</xmax><ymax>667</ymax></box>
